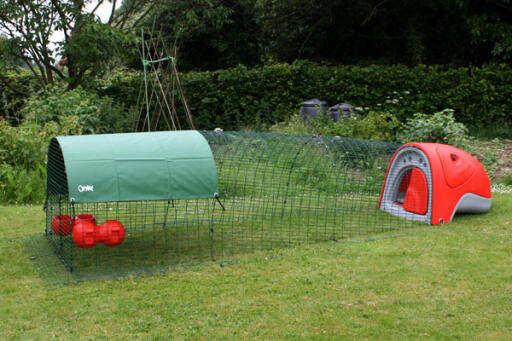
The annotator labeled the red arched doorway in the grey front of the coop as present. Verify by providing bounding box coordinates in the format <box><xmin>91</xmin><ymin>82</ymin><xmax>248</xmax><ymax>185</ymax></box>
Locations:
<box><xmin>396</xmin><ymin>167</ymin><xmax>428</xmax><ymax>214</ymax></box>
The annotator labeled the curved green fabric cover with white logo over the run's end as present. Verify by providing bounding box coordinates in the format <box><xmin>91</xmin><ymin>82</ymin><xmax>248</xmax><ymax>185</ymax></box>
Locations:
<box><xmin>47</xmin><ymin>131</ymin><xmax>218</xmax><ymax>203</ymax></box>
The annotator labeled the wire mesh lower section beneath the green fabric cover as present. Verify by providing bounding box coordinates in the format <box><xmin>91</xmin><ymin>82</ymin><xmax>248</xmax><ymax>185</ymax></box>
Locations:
<box><xmin>47</xmin><ymin>200</ymin><xmax>212</xmax><ymax>279</ymax></box>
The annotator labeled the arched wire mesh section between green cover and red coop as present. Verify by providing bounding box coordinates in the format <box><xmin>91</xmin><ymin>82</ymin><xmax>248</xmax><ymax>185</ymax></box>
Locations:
<box><xmin>203</xmin><ymin>132</ymin><xmax>410</xmax><ymax>259</ymax></box>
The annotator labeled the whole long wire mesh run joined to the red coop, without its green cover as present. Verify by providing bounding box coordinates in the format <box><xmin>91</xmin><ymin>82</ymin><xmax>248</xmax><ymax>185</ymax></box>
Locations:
<box><xmin>46</xmin><ymin>131</ymin><xmax>413</xmax><ymax>280</ymax></box>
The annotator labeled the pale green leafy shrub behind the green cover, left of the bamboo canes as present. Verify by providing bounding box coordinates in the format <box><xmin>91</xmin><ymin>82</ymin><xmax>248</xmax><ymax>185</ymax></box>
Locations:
<box><xmin>21</xmin><ymin>87</ymin><xmax>133</xmax><ymax>134</ymax></box>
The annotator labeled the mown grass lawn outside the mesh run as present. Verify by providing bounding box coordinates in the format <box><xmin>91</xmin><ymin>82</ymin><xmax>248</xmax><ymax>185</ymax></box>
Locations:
<box><xmin>0</xmin><ymin>194</ymin><xmax>512</xmax><ymax>340</ymax></box>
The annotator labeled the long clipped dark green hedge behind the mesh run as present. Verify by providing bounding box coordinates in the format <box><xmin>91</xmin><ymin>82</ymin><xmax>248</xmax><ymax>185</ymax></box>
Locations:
<box><xmin>103</xmin><ymin>61</ymin><xmax>512</xmax><ymax>130</ymax></box>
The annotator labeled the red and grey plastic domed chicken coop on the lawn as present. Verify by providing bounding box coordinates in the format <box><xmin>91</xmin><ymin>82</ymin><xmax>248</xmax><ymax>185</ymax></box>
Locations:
<box><xmin>379</xmin><ymin>143</ymin><xmax>491</xmax><ymax>225</ymax></box>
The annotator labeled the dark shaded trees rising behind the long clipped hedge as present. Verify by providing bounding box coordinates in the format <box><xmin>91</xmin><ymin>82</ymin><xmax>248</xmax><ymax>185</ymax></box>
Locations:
<box><xmin>134</xmin><ymin>0</ymin><xmax>512</xmax><ymax>70</ymax></box>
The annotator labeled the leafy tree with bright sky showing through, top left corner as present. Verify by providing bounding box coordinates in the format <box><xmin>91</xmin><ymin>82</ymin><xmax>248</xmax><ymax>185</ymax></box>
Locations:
<box><xmin>0</xmin><ymin>0</ymin><xmax>152</xmax><ymax>93</ymax></box>
